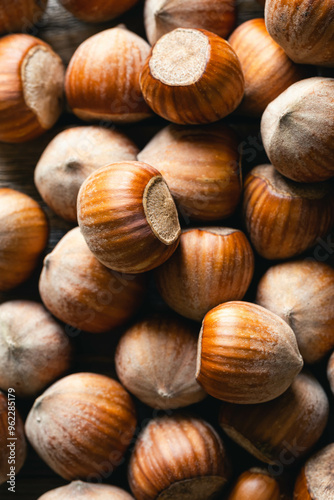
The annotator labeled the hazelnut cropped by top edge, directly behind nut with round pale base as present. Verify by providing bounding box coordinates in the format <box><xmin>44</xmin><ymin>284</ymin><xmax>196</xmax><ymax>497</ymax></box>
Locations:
<box><xmin>144</xmin><ymin>0</ymin><xmax>236</xmax><ymax>45</ymax></box>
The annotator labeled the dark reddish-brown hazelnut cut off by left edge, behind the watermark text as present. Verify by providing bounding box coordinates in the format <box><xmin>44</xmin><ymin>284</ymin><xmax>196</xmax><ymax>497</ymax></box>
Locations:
<box><xmin>0</xmin><ymin>391</ymin><xmax>27</xmax><ymax>484</ymax></box>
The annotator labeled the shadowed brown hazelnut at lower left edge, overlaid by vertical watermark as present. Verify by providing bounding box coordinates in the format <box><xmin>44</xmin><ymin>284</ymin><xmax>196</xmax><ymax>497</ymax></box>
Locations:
<box><xmin>0</xmin><ymin>392</ymin><xmax>27</xmax><ymax>484</ymax></box>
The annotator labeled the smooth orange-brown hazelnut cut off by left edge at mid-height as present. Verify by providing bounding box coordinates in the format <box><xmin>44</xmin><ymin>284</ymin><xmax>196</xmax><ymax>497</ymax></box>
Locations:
<box><xmin>0</xmin><ymin>188</ymin><xmax>48</xmax><ymax>291</ymax></box>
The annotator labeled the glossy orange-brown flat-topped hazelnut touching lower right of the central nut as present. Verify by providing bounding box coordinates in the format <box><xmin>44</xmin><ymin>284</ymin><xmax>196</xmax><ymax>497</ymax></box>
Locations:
<box><xmin>155</xmin><ymin>227</ymin><xmax>254</xmax><ymax>321</ymax></box>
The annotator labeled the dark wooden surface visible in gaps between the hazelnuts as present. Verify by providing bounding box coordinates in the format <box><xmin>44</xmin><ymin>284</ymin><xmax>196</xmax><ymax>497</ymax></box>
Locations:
<box><xmin>0</xmin><ymin>0</ymin><xmax>334</xmax><ymax>500</ymax></box>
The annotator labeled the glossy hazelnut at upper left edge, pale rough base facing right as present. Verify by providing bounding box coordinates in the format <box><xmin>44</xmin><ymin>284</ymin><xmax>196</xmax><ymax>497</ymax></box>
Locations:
<box><xmin>0</xmin><ymin>34</ymin><xmax>64</xmax><ymax>143</ymax></box>
